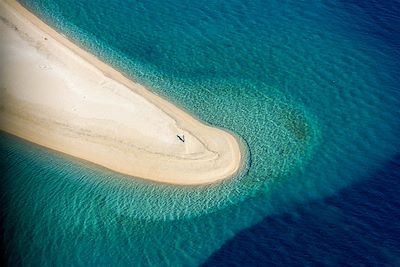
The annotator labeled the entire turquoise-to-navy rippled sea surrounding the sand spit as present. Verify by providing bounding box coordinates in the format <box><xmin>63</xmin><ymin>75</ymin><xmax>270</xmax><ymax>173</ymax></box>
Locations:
<box><xmin>0</xmin><ymin>0</ymin><xmax>400</xmax><ymax>266</ymax></box>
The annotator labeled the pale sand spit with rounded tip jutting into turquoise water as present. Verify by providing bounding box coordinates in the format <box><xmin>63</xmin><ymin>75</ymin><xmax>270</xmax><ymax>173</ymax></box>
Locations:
<box><xmin>0</xmin><ymin>0</ymin><xmax>241</xmax><ymax>185</ymax></box>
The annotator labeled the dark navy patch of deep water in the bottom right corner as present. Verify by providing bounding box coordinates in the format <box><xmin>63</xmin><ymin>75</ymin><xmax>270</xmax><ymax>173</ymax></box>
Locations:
<box><xmin>204</xmin><ymin>154</ymin><xmax>400</xmax><ymax>266</ymax></box>
